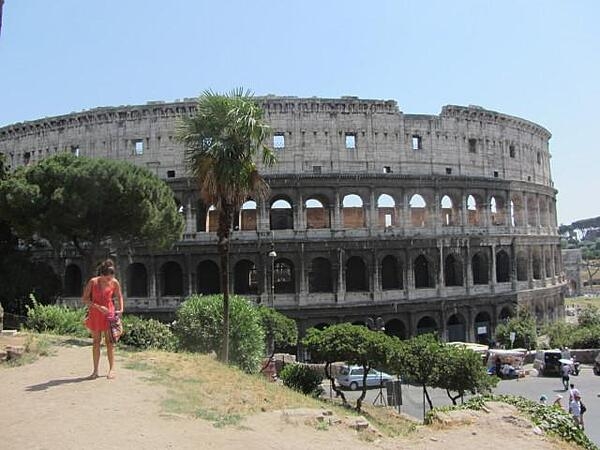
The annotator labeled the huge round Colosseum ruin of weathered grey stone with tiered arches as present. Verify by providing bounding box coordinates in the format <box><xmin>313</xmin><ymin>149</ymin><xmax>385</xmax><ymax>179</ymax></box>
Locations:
<box><xmin>0</xmin><ymin>96</ymin><xmax>564</xmax><ymax>342</ymax></box>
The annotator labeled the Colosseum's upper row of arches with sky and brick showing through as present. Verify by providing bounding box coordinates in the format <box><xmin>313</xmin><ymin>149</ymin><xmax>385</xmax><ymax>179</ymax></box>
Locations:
<box><xmin>189</xmin><ymin>193</ymin><xmax>555</xmax><ymax>232</ymax></box>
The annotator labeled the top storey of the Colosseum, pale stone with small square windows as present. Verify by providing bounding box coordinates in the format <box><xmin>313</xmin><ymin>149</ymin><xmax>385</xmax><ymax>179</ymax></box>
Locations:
<box><xmin>0</xmin><ymin>96</ymin><xmax>552</xmax><ymax>186</ymax></box>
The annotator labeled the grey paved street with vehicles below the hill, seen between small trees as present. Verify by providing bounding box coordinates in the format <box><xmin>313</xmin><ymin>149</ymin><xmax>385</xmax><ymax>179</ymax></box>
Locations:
<box><xmin>336</xmin><ymin>366</ymin><xmax>600</xmax><ymax>445</ymax></box>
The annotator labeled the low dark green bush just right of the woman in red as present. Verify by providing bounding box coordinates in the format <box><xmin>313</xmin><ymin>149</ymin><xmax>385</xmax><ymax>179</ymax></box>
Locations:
<box><xmin>121</xmin><ymin>316</ymin><xmax>177</xmax><ymax>351</ymax></box>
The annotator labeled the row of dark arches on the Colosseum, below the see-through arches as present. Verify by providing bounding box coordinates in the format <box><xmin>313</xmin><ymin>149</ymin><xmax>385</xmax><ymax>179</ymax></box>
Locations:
<box><xmin>65</xmin><ymin>247</ymin><xmax>555</xmax><ymax>297</ymax></box>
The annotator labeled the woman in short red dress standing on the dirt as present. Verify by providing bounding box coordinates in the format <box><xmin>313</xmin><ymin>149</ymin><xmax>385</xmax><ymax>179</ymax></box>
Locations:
<box><xmin>82</xmin><ymin>259</ymin><xmax>123</xmax><ymax>379</ymax></box>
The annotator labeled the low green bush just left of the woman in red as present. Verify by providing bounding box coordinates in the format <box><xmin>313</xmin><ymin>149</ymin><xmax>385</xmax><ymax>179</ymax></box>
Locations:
<box><xmin>25</xmin><ymin>299</ymin><xmax>89</xmax><ymax>337</ymax></box>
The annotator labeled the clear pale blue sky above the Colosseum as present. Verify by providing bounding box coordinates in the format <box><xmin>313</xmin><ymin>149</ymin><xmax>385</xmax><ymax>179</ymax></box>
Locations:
<box><xmin>0</xmin><ymin>0</ymin><xmax>600</xmax><ymax>224</ymax></box>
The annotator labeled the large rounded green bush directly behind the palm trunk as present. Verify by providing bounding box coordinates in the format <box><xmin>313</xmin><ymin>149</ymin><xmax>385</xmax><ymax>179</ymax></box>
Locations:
<box><xmin>173</xmin><ymin>295</ymin><xmax>265</xmax><ymax>373</ymax></box>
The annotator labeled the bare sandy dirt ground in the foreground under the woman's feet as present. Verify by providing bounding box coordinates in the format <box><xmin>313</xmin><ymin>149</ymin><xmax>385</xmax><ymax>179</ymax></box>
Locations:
<box><xmin>0</xmin><ymin>346</ymin><xmax>580</xmax><ymax>450</ymax></box>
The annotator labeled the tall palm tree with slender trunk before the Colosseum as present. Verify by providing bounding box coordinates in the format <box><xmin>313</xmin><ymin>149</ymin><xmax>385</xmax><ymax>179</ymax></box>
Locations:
<box><xmin>177</xmin><ymin>89</ymin><xmax>275</xmax><ymax>363</ymax></box>
